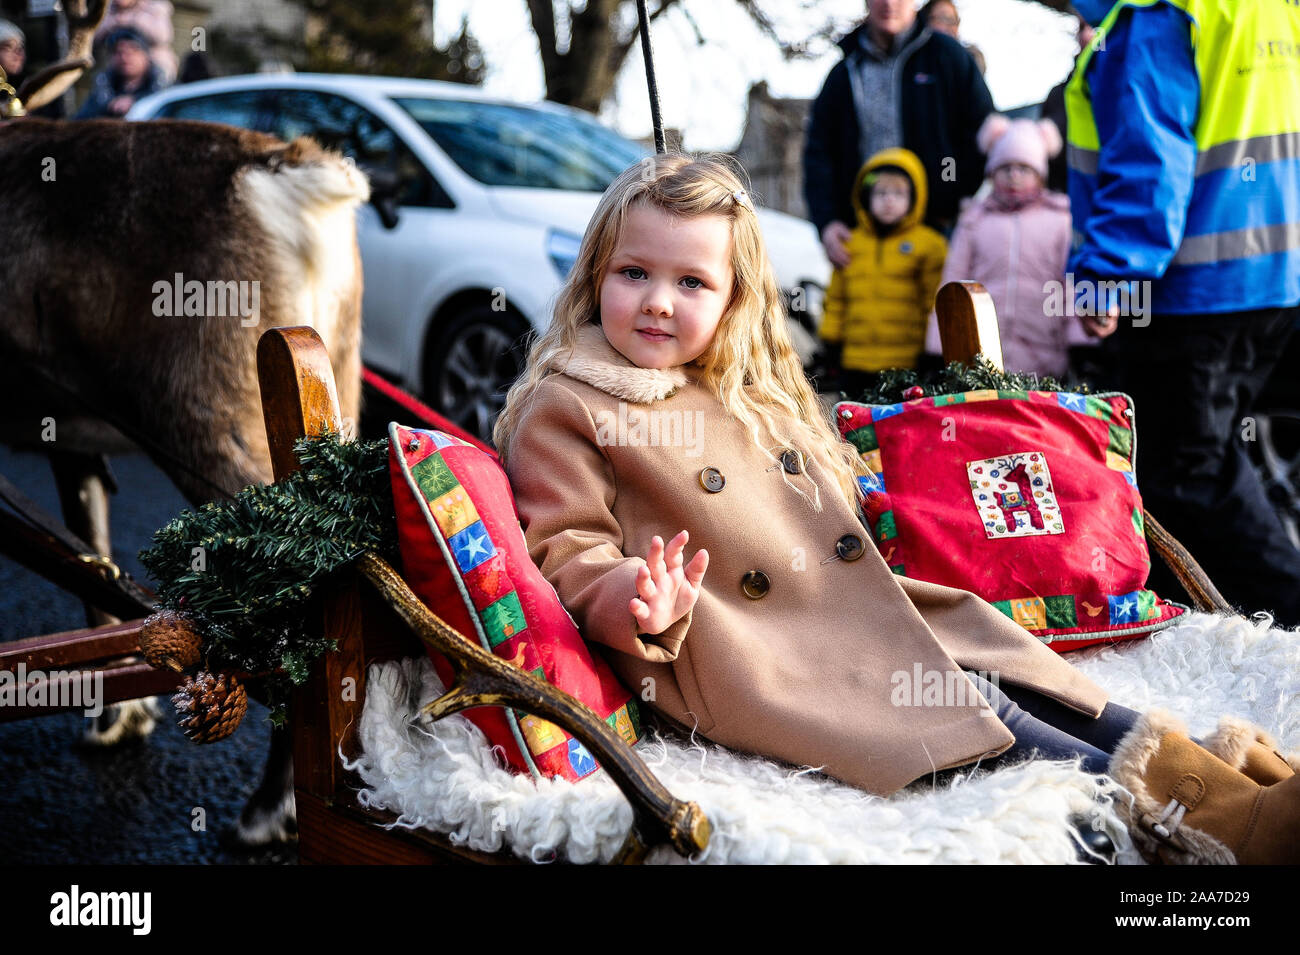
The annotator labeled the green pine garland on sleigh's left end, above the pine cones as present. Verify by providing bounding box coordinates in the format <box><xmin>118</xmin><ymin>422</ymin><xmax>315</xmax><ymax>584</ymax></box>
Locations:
<box><xmin>140</xmin><ymin>434</ymin><xmax>398</xmax><ymax>713</ymax></box>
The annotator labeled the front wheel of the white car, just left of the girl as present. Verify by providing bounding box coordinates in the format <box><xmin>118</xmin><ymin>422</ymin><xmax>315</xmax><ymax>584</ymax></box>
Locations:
<box><xmin>424</xmin><ymin>304</ymin><xmax>532</xmax><ymax>440</ymax></box>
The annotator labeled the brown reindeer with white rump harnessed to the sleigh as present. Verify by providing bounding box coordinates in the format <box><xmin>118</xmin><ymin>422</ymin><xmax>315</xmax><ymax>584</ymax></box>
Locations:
<box><xmin>0</xmin><ymin>0</ymin><xmax>369</xmax><ymax>845</ymax></box>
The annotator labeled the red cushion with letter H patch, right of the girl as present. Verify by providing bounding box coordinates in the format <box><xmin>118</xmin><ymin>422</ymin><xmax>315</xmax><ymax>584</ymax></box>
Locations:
<box><xmin>835</xmin><ymin>391</ymin><xmax>1186</xmax><ymax>651</ymax></box>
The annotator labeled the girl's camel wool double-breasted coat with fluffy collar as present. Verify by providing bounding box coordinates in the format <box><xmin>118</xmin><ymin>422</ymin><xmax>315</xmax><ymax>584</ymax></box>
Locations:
<box><xmin>507</xmin><ymin>325</ymin><xmax>1106</xmax><ymax>795</ymax></box>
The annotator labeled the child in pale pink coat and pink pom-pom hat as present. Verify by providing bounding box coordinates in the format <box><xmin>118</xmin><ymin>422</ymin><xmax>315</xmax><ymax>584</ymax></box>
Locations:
<box><xmin>926</xmin><ymin>113</ymin><xmax>1096</xmax><ymax>378</ymax></box>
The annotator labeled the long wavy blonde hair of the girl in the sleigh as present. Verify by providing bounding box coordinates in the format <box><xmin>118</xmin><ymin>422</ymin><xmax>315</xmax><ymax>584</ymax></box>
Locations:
<box><xmin>493</xmin><ymin>155</ymin><xmax>867</xmax><ymax>511</ymax></box>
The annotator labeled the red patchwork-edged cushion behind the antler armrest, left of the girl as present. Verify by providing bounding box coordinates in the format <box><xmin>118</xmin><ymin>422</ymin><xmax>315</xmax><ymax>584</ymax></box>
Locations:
<box><xmin>389</xmin><ymin>424</ymin><xmax>641</xmax><ymax>780</ymax></box>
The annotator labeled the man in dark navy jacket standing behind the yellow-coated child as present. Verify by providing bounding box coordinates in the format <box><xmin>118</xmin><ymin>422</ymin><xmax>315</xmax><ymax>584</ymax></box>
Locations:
<box><xmin>803</xmin><ymin>0</ymin><xmax>993</xmax><ymax>268</ymax></box>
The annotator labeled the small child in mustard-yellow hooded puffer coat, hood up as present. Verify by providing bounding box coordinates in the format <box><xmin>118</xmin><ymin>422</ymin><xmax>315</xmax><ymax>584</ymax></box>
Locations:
<box><xmin>818</xmin><ymin>149</ymin><xmax>948</xmax><ymax>398</ymax></box>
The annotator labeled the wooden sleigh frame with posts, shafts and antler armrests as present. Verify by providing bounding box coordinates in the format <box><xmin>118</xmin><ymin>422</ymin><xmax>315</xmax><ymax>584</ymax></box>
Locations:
<box><xmin>0</xmin><ymin>283</ymin><xmax>1231</xmax><ymax>864</ymax></box>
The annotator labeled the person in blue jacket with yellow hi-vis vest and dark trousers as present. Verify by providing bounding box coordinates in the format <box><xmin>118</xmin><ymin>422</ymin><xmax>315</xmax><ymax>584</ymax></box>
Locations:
<box><xmin>1066</xmin><ymin>0</ymin><xmax>1300</xmax><ymax>626</ymax></box>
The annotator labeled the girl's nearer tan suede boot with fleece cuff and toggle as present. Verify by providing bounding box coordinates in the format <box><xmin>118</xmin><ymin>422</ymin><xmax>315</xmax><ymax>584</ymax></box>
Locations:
<box><xmin>1110</xmin><ymin>709</ymin><xmax>1300</xmax><ymax>865</ymax></box>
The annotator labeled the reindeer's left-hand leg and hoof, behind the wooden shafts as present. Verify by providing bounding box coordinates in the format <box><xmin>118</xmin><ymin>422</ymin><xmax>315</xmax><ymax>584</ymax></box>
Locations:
<box><xmin>49</xmin><ymin>451</ymin><xmax>161</xmax><ymax>746</ymax></box>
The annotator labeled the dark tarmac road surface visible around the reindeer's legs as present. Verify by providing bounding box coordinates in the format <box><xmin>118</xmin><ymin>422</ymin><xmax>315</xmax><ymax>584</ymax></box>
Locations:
<box><xmin>0</xmin><ymin>448</ymin><xmax>296</xmax><ymax>864</ymax></box>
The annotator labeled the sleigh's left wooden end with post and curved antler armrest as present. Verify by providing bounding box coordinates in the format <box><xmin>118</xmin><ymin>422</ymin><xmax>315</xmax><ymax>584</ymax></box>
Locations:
<box><xmin>257</xmin><ymin>327</ymin><xmax>710</xmax><ymax>861</ymax></box>
